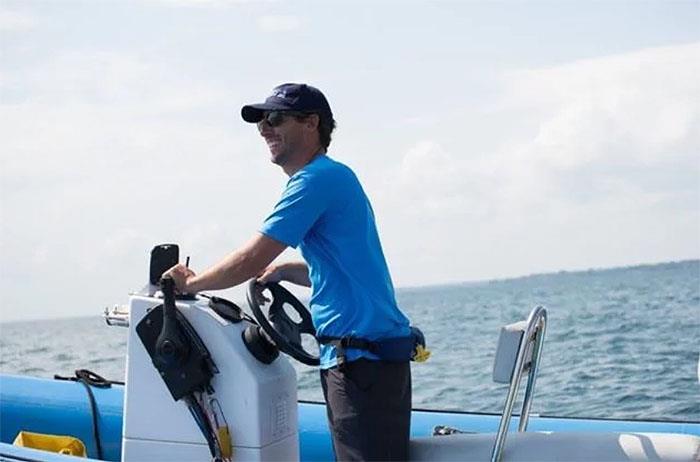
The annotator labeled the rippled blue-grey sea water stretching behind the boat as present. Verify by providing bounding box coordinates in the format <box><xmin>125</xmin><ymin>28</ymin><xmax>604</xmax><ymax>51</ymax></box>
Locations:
<box><xmin>0</xmin><ymin>260</ymin><xmax>700</xmax><ymax>421</ymax></box>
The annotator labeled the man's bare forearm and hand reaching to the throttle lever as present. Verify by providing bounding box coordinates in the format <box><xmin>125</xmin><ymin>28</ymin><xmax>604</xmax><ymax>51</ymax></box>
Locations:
<box><xmin>164</xmin><ymin>234</ymin><xmax>287</xmax><ymax>293</ymax></box>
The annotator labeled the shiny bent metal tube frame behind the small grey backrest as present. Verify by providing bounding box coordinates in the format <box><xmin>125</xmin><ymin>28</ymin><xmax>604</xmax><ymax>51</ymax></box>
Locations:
<box><xmin>491</xmin><ymin>306</ymin><xmax>547</xmax><ymax>462</ymax></box>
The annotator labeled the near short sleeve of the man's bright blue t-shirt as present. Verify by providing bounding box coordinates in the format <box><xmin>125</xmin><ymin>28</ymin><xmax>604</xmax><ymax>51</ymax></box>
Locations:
<box><xmin>260</xmin><ymin>171</ymin><xmax>330</xmax><ymax>248</ymax></box>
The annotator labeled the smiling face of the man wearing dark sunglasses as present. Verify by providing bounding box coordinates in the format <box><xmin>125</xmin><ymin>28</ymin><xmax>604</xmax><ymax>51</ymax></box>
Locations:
<box><xmin>258</xmin><ymin>112</ymin><xmax>304</xmax><ymax>166</ymax></box>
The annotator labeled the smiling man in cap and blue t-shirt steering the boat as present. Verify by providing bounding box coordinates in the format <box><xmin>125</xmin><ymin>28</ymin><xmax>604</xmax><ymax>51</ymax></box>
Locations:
<box><xmin>167</xmin><ymin>84</ymin><xmax>411</xmax><ymax>460</ymax></box>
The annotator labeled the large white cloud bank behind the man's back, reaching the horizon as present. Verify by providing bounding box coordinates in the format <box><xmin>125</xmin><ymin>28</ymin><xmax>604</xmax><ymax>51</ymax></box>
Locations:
<box><xmin>375</xmin><ymin>44</ymin><xmax>700</xmax><ymax>284</ymax></box>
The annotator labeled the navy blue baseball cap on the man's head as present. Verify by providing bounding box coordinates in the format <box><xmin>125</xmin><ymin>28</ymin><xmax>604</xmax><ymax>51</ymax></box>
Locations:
<box><xmin>241</xmin><ymin>83</ymin><xmax>333</xmax><ymax>124</ymax></box>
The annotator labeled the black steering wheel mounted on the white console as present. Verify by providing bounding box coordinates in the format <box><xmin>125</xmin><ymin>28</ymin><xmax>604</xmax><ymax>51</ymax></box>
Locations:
<box><xmin>248</xmin><ymin>279</ymin><xmax>321</xmax><ymax>366</ymax></box>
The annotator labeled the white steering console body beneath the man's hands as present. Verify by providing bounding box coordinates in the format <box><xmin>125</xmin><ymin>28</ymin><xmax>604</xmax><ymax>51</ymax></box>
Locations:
<box><xmin>122</xmin><ymin>295</ymin><xmax>299</xmax><ymax>462</ymax></box>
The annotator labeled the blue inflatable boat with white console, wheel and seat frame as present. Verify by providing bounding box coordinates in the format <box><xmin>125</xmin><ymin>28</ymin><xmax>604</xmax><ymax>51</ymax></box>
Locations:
<box><xmin>0</xmin><ymin>244</ymin><xmax>700</xmax><ymax>462</ymax></box>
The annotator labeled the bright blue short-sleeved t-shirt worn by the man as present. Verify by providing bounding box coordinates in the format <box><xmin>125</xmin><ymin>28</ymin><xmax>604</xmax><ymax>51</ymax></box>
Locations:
<box><xmin>260</xmin><ymin>155</ymin><xmax>410</xmax><ymax>369</ymax></box>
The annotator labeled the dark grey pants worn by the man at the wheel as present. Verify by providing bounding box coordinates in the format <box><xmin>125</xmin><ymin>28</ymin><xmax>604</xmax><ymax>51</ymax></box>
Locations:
<box><xmin>321</xmin><ymin>359</ymin><xmax>411</xmax><ymax>461</ymax></box>
